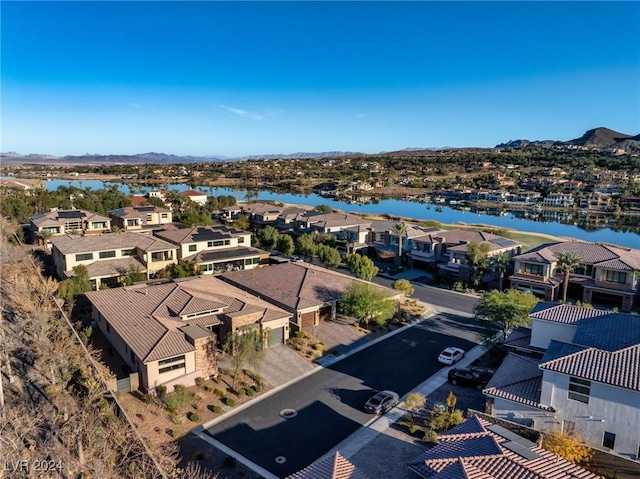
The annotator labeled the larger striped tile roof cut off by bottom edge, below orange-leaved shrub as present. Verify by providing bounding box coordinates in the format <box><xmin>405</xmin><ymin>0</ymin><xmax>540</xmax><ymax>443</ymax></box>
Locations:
<box><xmin>409</xmin><ymin>418</ymin><xmax>600</xmax><ymax>479</ymax></box>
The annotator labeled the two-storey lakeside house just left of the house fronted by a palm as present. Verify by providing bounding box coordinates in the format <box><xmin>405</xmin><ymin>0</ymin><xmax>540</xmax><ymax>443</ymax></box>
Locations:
<box><xmin>408</xmin><ymin>230</ymin><xmax>522</xmax><ymax>281</ymax></box>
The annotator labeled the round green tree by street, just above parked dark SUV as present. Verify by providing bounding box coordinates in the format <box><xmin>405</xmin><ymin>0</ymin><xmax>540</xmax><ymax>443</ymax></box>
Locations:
<box><xmin>474</xmin><ymin>289</ymin><xmax>538</xmax><ymax>341</ymax></box>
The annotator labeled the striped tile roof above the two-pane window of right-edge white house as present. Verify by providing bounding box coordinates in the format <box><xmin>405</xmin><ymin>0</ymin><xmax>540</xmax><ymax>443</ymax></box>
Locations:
<box><xmin>540</xmin><ymin>344</ymin><xmax>640</xmax><ymax>391</ymax></box>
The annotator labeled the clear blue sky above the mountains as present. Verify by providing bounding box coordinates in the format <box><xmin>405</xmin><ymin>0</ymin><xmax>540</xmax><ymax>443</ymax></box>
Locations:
<box><xmin>0</xmin><ymin>1</ymin><xmax>640</xmax><ymax>156</ymax></box>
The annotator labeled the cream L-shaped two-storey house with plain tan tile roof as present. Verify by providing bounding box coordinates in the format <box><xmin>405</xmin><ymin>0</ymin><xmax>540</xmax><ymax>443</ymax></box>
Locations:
<box><xmin>51</xmin><ymin>231</ymin><xmax>177</xmax><ymax>289</ymax></box>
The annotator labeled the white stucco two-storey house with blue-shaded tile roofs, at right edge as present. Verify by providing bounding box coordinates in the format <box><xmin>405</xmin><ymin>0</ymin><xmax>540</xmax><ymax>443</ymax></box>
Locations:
<box><xmin>483</xmin><ymin>303</ymin><xmax>640</xmax><ymax>460</ymax></box>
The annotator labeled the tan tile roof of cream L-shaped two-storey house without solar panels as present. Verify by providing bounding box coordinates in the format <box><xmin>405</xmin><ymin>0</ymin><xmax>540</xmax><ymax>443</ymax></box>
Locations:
<box><xmin>51</xmin><ymin>231</ymin><xmax>176</xmax><ymax>254</ymax></box>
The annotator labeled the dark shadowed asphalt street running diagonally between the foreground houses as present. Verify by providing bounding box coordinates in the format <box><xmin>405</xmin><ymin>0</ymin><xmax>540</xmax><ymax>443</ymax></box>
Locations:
<box><xmin>206</xmin><ymin>310</ymin><xmax>482</xmax><ymax>477</ymax></box>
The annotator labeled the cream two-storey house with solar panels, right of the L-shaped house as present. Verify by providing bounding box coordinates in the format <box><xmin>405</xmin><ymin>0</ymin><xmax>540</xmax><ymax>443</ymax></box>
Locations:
<box><xmin>155</xmin><ymin>226</ymin><xmax>269</xmax><ymax>274</ymax></box>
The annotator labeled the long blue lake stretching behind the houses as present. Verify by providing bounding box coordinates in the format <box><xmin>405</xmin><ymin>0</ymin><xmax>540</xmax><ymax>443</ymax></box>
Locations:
<box><xmin>47</xmin><ymin>180</ymin><xmax>640</xmax><ymax>248</ymax></box>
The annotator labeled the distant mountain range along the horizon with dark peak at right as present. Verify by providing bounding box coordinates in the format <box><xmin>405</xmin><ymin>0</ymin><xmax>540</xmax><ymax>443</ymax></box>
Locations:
<box><xmin>0</xmin><ymin>127</ymin><xmax>640</xmax><ymax>165</ymax></box>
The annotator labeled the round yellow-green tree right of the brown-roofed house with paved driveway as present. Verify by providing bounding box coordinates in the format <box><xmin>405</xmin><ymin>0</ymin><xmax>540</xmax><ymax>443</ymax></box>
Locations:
<box><xmin>338</xmin><ymin>281</ymin><xmax>396</xmax><ymax>325</ymax></box>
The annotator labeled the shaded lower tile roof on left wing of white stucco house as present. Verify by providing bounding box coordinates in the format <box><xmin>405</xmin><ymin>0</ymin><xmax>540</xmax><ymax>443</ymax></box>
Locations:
<box><xmin>482</xmin><ymin>353</ymin><xmax>548</xmax><ymax>410</ymax></box>
